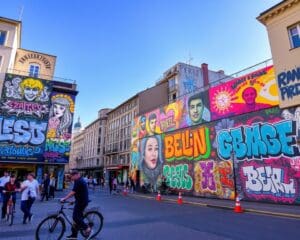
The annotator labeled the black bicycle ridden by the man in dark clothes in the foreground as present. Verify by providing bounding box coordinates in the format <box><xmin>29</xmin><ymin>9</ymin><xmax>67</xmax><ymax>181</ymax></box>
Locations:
<box><xmin>35</xmin><ymin>201</ymin><xmax>104</xmax><ymax>240</ymax></box>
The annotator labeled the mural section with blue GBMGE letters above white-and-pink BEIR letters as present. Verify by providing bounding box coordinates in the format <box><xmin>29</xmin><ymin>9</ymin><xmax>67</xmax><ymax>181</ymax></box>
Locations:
<box><xmin>217</xmin><ymin>107</ymin><xmax>300</xmax><ymax>204</ymax></box>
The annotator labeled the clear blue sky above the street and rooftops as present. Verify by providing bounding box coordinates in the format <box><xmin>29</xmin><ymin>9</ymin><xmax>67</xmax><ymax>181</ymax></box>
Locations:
<box><xmin>0</xmin><ymin>0</ymin><xmax>279</xmax><ymax>126</ymax></box>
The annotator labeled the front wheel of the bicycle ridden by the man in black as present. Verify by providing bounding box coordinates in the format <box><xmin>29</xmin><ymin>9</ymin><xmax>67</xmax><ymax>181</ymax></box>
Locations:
<box><xmin>35</xmin><ymin>215</ymin><xmax>66</xmax><ymax>240</ymax></box>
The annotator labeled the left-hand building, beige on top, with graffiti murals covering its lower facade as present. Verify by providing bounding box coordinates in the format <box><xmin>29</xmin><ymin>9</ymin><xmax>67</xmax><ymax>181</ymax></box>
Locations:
<box><xmin>0</xmin><ymin>17</ymin><xmax>78</xmax><ymax>189</ymax></box>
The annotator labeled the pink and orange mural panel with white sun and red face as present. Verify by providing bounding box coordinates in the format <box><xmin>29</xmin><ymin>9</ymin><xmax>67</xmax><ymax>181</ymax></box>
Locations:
<box><xmin>209</xmin><ymin>66</ymin><xmax>279</xmax><ymax>120</ymax></box>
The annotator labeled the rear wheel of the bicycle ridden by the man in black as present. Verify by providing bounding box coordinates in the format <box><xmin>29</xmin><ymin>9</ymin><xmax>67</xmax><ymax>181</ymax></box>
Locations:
<box><xmin>80</xmin><ymin>211</ymin><xmax>104</xmax><ymax>239</ymax></box>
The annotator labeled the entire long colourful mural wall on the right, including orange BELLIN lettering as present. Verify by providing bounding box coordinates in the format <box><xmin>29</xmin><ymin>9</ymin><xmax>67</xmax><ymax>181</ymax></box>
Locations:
<box><xmin>131</xmin><ymin>67</ymin><xmax>300</xmax><ymax>204</ymax></box>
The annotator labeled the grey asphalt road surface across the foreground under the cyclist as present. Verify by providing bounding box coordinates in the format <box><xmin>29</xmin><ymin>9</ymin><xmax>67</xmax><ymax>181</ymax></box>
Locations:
<box><xmin>0</xmin><ymin>190</ymin><xmax>300</xmax><ymax>240</ymax></box>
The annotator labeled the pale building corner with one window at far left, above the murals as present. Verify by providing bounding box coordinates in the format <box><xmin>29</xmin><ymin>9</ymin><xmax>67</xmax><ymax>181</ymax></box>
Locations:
<box><xmin>0</xmin><ymin>17</ymin><xmax>22</xmax><ymax>91</ymax></box>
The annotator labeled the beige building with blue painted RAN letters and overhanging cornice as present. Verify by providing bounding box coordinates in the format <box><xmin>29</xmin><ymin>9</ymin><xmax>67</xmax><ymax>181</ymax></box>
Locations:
<box><xmin>257</xmin><ymin>0</ymin><xmax>300</xmax><ymax>108</ymax></box>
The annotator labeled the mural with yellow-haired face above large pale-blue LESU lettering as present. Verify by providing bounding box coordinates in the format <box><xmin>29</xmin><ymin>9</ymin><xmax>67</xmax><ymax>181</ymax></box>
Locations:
<box><xmin>0</xmin><ymin>74</ymin><xmax>52</xmax><ymax>162</ymax></box>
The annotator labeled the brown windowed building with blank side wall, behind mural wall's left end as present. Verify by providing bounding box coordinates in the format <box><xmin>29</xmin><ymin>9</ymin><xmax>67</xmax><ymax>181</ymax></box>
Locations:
<box><xmin>104</xmin><ymin>82</ymin><xmax>168</xmax><ymax>183</ymax></box>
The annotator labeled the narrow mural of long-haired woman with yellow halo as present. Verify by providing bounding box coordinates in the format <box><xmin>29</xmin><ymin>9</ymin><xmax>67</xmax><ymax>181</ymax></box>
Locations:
<box><xmin>44</xmin><ymin>91</ymin><xmax>75</xmax><ymax>163</ymax></box>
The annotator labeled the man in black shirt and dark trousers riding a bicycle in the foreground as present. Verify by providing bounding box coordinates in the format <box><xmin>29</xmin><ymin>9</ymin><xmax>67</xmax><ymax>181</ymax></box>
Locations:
<box><xmin>61</xmin><ymin>170</ymin><xmax>91</xmax><ymax>239</ymax></box>
